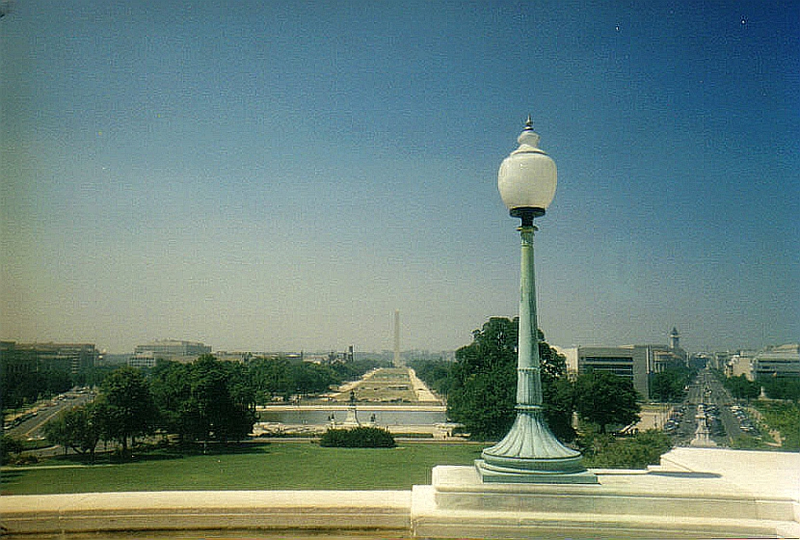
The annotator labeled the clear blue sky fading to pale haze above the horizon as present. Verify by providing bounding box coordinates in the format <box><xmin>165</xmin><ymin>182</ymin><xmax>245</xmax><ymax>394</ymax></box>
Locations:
<box><xmin>0</xmin><ymin>0</ymin><xmax>800</xmax><ymax>352</ymax></box>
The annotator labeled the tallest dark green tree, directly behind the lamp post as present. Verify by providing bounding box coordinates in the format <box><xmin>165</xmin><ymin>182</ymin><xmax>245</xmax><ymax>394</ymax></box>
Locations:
<box><xmin>447</xmin><ymin>317</ymin><xmax>574</xmax><ymax>439</ymax></box>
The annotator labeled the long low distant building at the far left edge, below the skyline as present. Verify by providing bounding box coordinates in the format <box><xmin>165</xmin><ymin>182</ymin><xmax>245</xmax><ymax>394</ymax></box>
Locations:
<box><xmin>0</xmin><ymin>341</ymin><xmax>100</xmax><ymax>375</ymax></box>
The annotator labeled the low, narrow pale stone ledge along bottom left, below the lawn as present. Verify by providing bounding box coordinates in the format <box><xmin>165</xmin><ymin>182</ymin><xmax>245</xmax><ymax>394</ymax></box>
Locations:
<box><xmin>0</xmin><ymin>491</ymin><xmax>411</xmax><ymax>534</ymax></box>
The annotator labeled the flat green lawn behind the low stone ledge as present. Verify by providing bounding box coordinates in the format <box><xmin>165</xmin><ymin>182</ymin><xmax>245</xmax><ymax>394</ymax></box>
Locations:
<box><xmin>0</xmin><ymin>442</ymin><xmax>483</xmax><ymax>495</ymax></box>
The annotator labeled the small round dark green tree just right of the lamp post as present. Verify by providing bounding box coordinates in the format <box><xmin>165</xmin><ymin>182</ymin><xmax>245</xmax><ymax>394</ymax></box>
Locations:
<box><xmin>574</xmin><ymin>370</ymin><xmax>641</xmax><ymax>433</ymax></box>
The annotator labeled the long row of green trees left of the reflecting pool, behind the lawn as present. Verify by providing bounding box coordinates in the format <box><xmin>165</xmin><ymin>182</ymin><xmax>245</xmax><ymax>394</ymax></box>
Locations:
<box><xmin>45</xmin><ymin>355</ymin><xmax>388</xmax><ymax>456</ymax></box>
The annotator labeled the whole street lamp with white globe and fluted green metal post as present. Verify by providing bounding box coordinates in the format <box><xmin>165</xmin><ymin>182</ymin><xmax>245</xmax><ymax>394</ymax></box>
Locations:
<box><xmin>475</xmin><ymin>117</ymin><xmax>597</xmax><ymax>484</ymax></box>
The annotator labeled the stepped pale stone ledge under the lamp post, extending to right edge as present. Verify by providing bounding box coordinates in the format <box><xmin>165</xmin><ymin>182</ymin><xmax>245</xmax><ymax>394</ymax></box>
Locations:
<box><xmin>411</xmin><ymin>448</ymin><xmax>800</xmax><ymax>538</ymax></box>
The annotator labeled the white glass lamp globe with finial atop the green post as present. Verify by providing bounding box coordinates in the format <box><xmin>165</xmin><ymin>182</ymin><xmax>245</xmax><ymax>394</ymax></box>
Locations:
<box><xmin>497</xmin><ymin>118</ymin><xmax>557</xmax><ymax>216</ymax></box>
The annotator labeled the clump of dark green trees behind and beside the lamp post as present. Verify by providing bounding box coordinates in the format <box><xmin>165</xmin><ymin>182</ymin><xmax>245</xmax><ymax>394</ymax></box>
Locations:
<box><xmin>414</xmin><ymin>317</ymin><xmax>640</xmax><ymax>441</ymax></box>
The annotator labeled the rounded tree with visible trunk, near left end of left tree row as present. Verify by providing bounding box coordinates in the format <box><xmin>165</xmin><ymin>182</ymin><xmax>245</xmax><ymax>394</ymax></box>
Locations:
<box><xmin>98</xmin><ymin>367</ymin><xmax>158</xmax><ymax>455</ymax></box>
